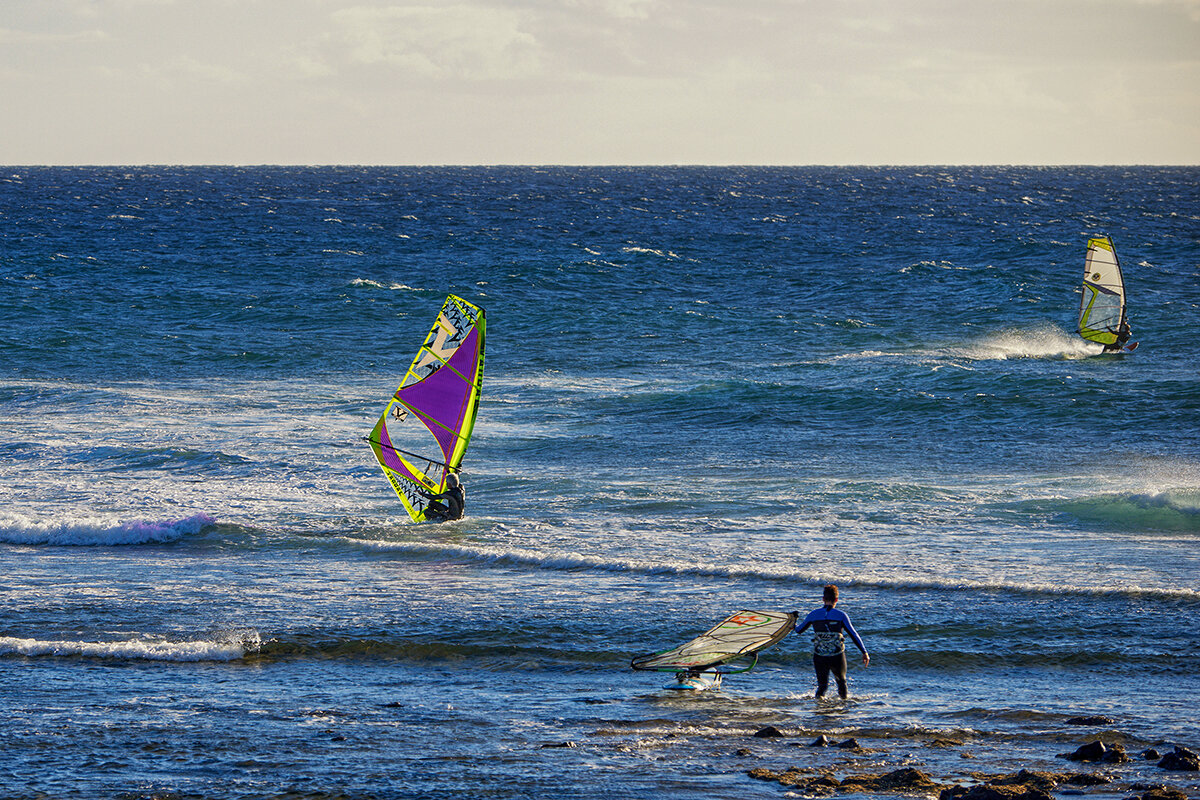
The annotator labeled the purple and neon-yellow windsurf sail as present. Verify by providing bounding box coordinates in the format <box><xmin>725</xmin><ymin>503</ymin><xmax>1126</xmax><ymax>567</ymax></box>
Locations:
<box><xmin>366</xmin><ymin>295</ymin><xmax>486</xmax><ymax>522</ymax></box>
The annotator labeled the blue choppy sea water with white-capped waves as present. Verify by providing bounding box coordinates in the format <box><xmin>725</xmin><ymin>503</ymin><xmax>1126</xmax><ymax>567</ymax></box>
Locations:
<box><xmin>0</xmin><ymin>167</ymin><xmax>1200</xmax><ymax>800</ymax></box>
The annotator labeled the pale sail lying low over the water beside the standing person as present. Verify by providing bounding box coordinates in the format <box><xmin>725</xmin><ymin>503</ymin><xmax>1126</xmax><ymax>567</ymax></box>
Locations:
<box><xmin>630</xmin><ymin>610</ymin><xmax>797</xmax><ymax>672</ymax></box>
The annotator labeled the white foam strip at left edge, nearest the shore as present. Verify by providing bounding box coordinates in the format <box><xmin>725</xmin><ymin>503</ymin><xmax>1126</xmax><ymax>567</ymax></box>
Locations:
<box><xmin>0</xmin><ymin>631</ymin><xmax>262</xmax><ymax>661</ymax></box>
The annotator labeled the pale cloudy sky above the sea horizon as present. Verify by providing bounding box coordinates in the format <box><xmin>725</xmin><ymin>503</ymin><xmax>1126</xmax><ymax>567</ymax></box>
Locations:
<box><xmin>0</xmin><ymin>0</ymin><xmax>1200</xmax><ymax>164</ymax></box>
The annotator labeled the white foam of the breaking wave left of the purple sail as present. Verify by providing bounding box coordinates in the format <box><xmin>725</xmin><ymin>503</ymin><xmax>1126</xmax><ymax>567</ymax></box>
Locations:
<box><xmin>0</xmin><ymin>512</ymin><xmax>216</xmax><ymax>547</ymax></box>
